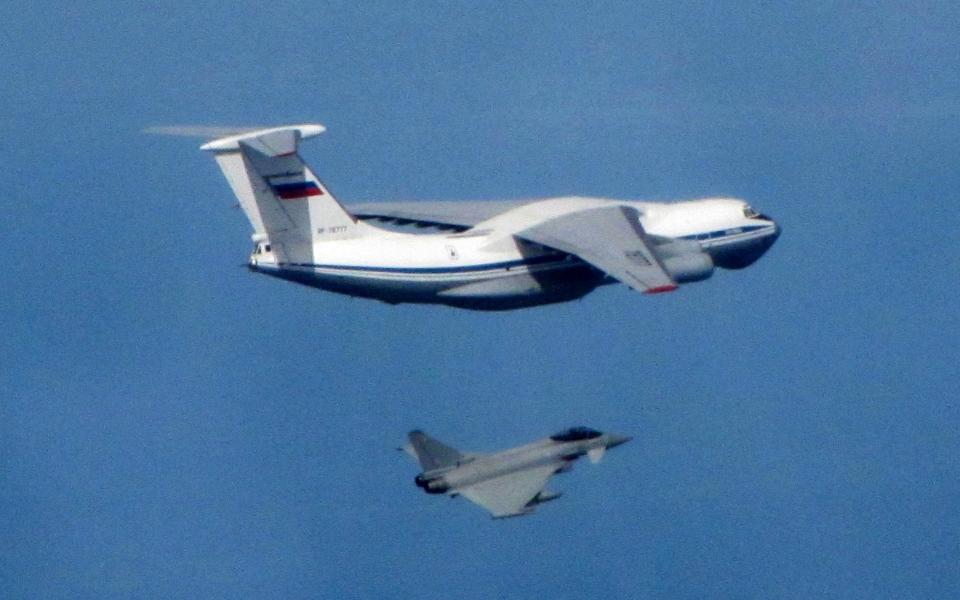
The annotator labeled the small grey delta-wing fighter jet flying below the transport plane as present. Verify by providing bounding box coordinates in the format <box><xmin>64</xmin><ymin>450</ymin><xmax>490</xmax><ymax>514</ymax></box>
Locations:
<box><xmin>402</xmin><ymin>427</ymin><xmax>632</xmax><ymax>519</ymax></box>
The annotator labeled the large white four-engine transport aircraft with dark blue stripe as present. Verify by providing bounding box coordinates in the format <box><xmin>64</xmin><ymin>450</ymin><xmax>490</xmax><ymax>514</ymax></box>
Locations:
<box><xmin>202</xmin><ymin>125</ymin><xmax>780</xmax><ymax>310</ymax></box>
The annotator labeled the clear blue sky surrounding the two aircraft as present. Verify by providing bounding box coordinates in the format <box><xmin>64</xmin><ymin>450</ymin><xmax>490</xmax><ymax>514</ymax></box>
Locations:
<box><xmin>0</xmin><ymin>2</ymin><xmax>960</xmax><ymax>598</ymax></box>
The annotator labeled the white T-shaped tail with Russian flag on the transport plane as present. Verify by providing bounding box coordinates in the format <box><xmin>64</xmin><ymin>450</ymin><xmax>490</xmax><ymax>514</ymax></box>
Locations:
<box><xmin>201</xmin><ymin>125</ymin><xmax>370</xmax><ymax>263</ymax></box>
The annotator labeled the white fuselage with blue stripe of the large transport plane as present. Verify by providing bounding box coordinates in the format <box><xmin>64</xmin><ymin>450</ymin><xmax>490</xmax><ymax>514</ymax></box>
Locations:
<box><xmin>250</xmin><ymin>198</ymin><xmax>779</xmax><ymax>309</ymax></box>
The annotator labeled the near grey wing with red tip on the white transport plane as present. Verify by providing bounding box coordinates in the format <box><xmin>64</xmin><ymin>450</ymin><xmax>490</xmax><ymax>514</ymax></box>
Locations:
<box><xmin>514</xmin><ymin>205</ymin><xmax>677</xmax><ymax>294</ymax></box>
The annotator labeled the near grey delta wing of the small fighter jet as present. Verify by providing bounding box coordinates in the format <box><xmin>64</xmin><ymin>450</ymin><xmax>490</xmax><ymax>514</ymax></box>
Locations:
<box><xmin>457</xmin><ymin>464</ymin><xmax>559</xmax><ymax>519</ymax></box>
